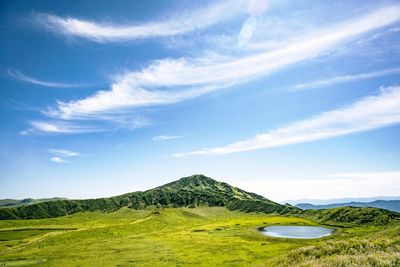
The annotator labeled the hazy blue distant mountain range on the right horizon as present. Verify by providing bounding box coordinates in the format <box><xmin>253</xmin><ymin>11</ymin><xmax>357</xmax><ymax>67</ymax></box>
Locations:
<box><xmin>296</xmin><ymin>200</ymin><xmax>400</xmax><ymax>212</ymax></box>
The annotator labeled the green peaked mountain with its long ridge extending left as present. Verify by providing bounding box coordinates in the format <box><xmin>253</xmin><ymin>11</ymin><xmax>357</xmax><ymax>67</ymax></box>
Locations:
<box><xmin>0</xmin><ymin>175</ymin><xmax>299</xmax><ymax>219</ymax></box>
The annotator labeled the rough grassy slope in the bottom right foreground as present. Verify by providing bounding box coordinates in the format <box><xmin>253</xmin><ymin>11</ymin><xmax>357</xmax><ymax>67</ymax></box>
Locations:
<box><xmin>273</xmin><ymin>224</ymin><xmax>400</xmax><ymax>267</ymax></box>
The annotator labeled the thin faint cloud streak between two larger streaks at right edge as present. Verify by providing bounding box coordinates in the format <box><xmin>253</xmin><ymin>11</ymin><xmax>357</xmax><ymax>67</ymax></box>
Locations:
<box><xmin>290</xmin><ymin>68</ymin><xmax>400</xmax><ymax>91</ymax></box>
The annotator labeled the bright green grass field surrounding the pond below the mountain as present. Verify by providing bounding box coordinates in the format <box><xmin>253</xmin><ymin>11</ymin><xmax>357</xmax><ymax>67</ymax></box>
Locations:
<box><xmin>0</xmin><ymin>207</ymin><xmax>400</xmax><ymax>266</ymax></box>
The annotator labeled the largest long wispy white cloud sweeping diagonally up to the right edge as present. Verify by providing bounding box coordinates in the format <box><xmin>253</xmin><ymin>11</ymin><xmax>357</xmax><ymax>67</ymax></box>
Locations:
<box><xmin>47</xmin><ymin>6</ymin><xmax>400</xmax><ymax>120</ymax></box>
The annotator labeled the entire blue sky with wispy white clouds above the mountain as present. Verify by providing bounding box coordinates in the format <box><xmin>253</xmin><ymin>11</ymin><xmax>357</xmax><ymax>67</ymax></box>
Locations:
<box><xmin>0</xmin><ymin>0</ymin><xmax>400</xmax><ymax>201</ymax></box>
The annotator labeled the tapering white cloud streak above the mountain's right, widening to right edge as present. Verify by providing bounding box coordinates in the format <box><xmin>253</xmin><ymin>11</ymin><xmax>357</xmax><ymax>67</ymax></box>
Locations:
<box><xmin>174</xmin><ymin>87</ymin><xmax>400</xmax><ymax>156</ymax></box>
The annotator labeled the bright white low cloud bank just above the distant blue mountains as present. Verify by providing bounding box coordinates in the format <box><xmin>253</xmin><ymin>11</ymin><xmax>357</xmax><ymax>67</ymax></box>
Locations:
<box><xmin>234</xmin><ymin>171</ymin><xmax>400</xmax><ymax>201</ymax></box>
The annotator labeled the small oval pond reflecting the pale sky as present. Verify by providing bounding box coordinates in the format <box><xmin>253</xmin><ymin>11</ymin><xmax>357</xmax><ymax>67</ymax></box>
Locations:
<box><xmin>259</xmin><ymin>225</ymin><xmax>333</xmax><ymax>239</ymax></box>
